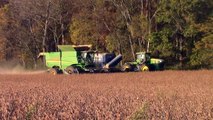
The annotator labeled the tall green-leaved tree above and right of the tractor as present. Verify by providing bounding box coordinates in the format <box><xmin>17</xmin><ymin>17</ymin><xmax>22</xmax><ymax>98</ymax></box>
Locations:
<box><xmin>152</xmin><ymin>0</ymin><xmax>211</xmax><ymax>68</ymax></box>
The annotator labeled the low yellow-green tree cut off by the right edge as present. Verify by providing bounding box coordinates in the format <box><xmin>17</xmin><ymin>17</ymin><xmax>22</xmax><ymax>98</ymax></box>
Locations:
<box><xmin>190</xmin><ymin>17</ymin><xmax>213</xmax><ymax>69</ymax></box>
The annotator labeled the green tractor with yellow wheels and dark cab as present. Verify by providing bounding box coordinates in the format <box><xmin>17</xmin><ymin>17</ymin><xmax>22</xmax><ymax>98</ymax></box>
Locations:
<box><xmin>122</xmin><ymin>52</ymin><xmax>164</xmax><ymax>71</ymax></box>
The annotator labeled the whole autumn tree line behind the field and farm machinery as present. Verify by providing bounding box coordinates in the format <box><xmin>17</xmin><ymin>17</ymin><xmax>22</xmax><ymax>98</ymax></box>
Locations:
<box><xmin>0</xmin><ymin>0</ymin><xmax>213</xmax><ymax>69</ymax></box>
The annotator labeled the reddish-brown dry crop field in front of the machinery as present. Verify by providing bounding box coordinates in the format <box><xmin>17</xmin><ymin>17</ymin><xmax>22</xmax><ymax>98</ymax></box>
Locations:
<box><xmin>0</xmin><ymin>70</ymin><xmax>213</xmax><ymax>120</ymax></box>
